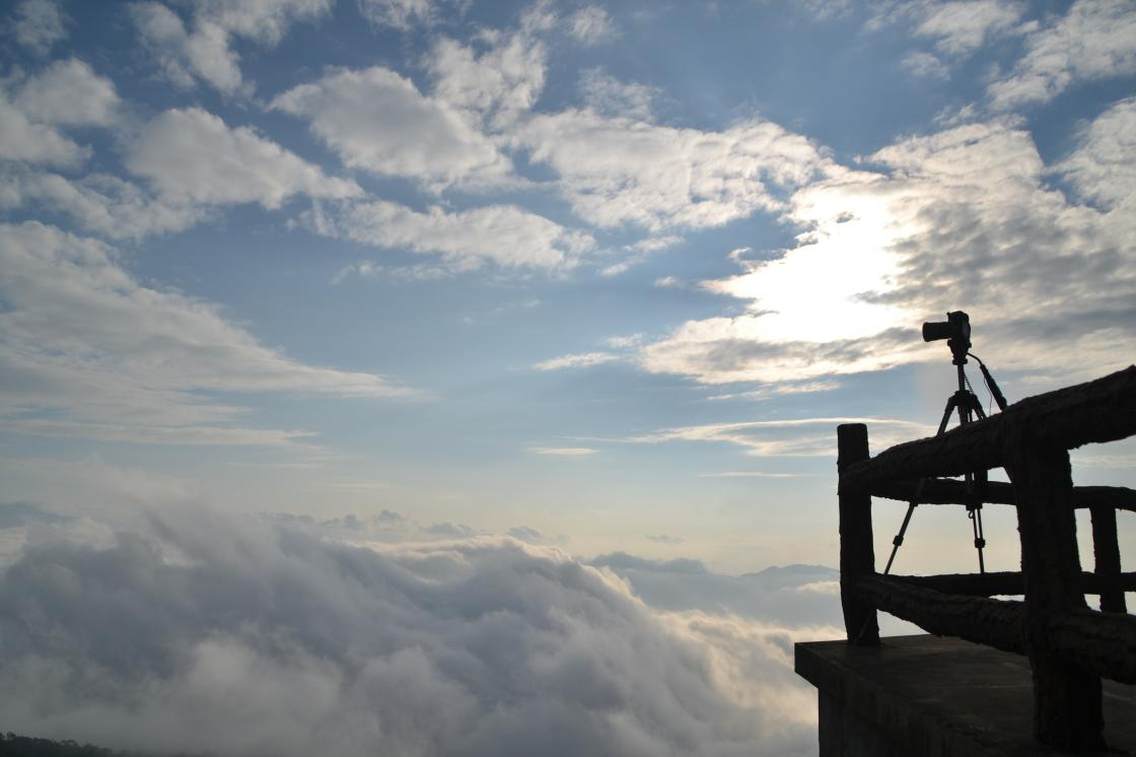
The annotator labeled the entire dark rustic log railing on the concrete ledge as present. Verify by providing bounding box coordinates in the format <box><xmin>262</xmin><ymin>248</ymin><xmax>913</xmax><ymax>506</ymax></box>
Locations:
<box><xmin>837</xmin><ymin>366</ymin><xmax>1136</xmax><ymax>751</ymax></box>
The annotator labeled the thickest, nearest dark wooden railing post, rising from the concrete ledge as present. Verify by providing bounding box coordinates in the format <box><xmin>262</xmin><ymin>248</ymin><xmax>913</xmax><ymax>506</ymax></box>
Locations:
<box><xmin>1003</xmin><ymin>429</ymin><xmax>1104</xmax><ymax>751</ymax></box>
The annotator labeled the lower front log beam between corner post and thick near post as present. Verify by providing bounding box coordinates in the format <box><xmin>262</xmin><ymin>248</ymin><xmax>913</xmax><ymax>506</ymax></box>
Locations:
<box><xmin>855</xmin><ymin>574</ymin><xmax>1025</xmax><ymax>654</ymax></box>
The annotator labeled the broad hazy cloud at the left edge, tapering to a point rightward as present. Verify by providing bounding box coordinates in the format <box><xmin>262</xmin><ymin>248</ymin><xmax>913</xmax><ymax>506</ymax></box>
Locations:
<box><xmin>0</xmin><ymin>223</ymin><xmax>409</xmax><ymax>444</ymax></box>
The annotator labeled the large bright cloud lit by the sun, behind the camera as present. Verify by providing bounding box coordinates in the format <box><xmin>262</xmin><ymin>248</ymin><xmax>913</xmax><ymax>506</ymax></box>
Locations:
<box><xmin>640</xmin><ymin>122</ymin><xmax>1136</xmax><ymax>384</ymax></box>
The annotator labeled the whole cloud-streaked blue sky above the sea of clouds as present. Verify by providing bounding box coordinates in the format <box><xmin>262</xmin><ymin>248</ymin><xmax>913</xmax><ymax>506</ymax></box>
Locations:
<box><xmin>0</xmin><ymin>0</ymin><xmax>1136</xmax><ymax>573</ymax></box>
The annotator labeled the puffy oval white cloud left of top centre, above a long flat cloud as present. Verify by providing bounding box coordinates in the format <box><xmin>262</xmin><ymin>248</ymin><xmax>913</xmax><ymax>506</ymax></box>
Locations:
<box><xmin>272</xmin><ymin>67</ymin><xmax>511</xmax><ymax>189</ymax></box>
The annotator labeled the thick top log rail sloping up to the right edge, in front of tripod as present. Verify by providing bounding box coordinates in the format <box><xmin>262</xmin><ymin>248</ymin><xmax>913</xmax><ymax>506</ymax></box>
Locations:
<box><xmin>840</xmin><ymin>366</ymin><xmax>1136</xmax><ymax>492</ymax></box>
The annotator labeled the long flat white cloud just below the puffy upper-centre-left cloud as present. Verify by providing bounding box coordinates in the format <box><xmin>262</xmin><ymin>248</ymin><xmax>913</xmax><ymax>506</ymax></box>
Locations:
<box><xmin>302</xmin><ymin>200</ymin><xmax>594</xmax><ymax>269</ymax></box>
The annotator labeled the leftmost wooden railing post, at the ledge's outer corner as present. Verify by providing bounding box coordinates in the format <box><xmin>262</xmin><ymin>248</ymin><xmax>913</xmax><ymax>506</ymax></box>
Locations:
<box><xmin>836</xmin><ymin>423</ymin><xmax>879</xmax><ymax>646</ymax></box>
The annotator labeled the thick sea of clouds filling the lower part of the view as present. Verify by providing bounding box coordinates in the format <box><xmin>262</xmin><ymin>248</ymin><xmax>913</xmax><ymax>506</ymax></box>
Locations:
<box><xmin>0</xmin><ymin>495</ymin><xmax>867</xmax><ymax>757</ymax></box>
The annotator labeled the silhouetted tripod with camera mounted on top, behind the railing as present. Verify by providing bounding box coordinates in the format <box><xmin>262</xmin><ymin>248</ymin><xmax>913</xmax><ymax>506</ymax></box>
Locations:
<box><xmin>884</xmin><ymin>310</ymin><xmax>1006</xmax><ymax>575</ymax></box>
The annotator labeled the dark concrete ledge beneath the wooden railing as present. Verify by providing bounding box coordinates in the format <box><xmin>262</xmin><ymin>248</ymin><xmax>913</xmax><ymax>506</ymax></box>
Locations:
<box><xmin>795</xmin><ymin>635</ymin><xmax>1136</xmax><ymax>757</ymax></box>
